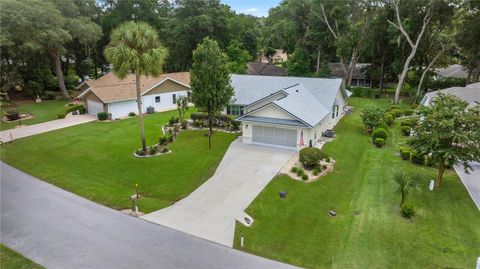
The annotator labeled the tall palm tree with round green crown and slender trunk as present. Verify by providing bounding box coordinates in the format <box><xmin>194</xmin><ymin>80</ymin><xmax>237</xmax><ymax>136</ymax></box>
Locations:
<box><xmin>104</xmin><ymin>21</ymin><xmax>167</xmax><ymax>152</ymax></box>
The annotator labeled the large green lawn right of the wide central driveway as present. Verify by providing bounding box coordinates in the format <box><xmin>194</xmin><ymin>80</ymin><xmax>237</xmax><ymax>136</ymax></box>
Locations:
<box><xmin>235</xmin><ymin>98</ymin><xmax>480</xmax><ymax>268</ymax></box>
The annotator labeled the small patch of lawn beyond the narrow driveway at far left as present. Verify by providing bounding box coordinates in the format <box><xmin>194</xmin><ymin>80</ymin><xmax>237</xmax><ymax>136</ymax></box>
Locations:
<box><xmin>0</xmin><ymin>100</ymin><xmax>68</xmax><ymax>131</ymax></box>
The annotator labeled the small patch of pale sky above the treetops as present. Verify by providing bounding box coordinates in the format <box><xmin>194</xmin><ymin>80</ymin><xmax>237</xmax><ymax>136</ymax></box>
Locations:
<box><xmin>221</xmin><ymin>0</ymin><xmax>280</xmax><ymax>17</ymax></box>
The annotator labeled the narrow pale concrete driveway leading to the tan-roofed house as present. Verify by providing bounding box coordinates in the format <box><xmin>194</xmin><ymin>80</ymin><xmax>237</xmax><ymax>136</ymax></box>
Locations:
<box><xmin>0</xmin><ymin>114</ymin><xmax>97</xmax><ymax>142</ymax></box>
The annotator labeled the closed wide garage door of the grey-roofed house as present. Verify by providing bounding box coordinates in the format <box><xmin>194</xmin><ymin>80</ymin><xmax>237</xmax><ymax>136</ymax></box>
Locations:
<box><xmin>252</xmin><ymin>125</ymin><xmax>297</xmax><ymax>148</ymax></box>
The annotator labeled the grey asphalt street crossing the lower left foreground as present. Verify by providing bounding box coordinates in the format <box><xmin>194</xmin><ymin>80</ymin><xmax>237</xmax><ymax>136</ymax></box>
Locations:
<box><xmin>0</xmin><ymin>163</ymin><xmax>298</xmax><ymax>269</ymax></box>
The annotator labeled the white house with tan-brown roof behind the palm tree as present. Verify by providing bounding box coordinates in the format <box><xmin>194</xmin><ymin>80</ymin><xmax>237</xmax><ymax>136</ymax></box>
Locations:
<box><xmin>78</xmin><ymin>72</ymin><xmax>190</xmax><ymax>119</ymax></box>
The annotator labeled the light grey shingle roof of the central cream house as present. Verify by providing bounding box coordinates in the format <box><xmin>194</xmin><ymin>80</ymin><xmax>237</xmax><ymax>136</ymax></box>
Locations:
<box><xmin>231</xmin><ymin>75</ymin><xmax>348</xmax><ymax>127</ymax></box>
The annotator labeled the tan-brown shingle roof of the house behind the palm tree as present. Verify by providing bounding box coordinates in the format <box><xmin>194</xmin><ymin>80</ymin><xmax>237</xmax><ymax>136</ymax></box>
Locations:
<box><xmin>78</xmin><ymin>72</ymin><xmax>190</xmax><ymax>103</ymax></box>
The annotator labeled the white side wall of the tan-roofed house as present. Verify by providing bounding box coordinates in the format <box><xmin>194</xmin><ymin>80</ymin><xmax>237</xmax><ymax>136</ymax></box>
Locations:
<box><xmin>108</xmin><ymin>91</ymin><xmax>187</xmax><ymax>119</ymax></box>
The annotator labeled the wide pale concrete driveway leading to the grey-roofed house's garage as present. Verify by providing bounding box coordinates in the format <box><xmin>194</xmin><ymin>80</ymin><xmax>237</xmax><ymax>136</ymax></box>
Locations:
<box><xmin>142</xmin><ymin>139</ymin><xmax>295</xmax><ymax>247</ymax></box>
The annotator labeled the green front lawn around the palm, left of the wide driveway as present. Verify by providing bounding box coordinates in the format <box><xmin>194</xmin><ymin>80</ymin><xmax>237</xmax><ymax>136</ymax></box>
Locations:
<box><xmin>1</xmin><ymin>108</ymin><xmax>236</xmax><ymax>213</ymax></box>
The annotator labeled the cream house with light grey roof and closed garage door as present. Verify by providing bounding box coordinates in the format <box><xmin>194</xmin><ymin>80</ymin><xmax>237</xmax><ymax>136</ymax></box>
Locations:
<box><xmin>226</xmin><ymin>75</ymin><xmax>351</xmax><ymax>149</ymax></box>
